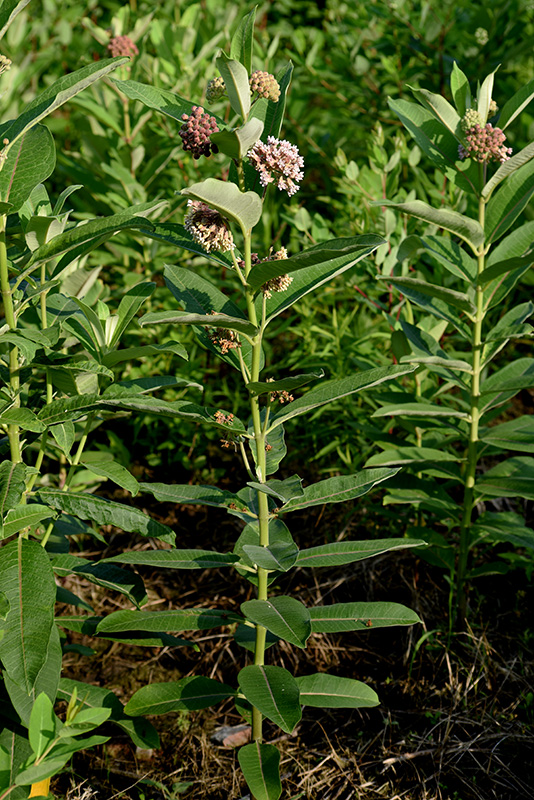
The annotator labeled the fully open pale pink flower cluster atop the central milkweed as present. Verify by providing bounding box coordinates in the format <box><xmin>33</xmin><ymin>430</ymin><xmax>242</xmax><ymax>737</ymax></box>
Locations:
<box><xmin>248</xmin><ymin>136</ymin><xmax>304</xmax><ymax>197</ymax></box>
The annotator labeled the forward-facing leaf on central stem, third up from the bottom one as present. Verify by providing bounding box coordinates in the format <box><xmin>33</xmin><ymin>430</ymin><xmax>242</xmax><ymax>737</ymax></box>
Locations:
<box><xmin>241</xmin><ymin>595</ymin><xmax>311</xmax><ymax>648</ymax></box>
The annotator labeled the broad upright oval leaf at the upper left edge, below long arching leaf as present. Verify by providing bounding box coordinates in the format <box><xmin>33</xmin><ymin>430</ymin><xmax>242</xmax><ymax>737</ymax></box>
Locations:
<box><xmin>0</xmin><ymin>125</ymin><xmax>56</xmax><ymax>214</ymax></box>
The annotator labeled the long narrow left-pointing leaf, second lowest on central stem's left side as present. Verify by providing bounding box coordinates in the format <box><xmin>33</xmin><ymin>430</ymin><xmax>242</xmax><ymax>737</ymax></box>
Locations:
<box><xmin>97</xmin><ymin>608</ymin><xmax>243</xmax><ymax>633</ymax></box>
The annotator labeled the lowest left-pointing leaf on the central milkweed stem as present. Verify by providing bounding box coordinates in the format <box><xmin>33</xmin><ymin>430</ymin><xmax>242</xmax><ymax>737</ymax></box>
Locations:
<box><xmin>124</xmin><ymin>677</ymin><xmax>235</xmax><ymax>717</ymax></box>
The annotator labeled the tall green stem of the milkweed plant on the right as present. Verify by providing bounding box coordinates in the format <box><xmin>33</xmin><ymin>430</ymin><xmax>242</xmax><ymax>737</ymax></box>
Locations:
<box><xmin>456</xmin><ymin>192</ymin><xmax>486</xmax><ymax>623</ymax></box>
